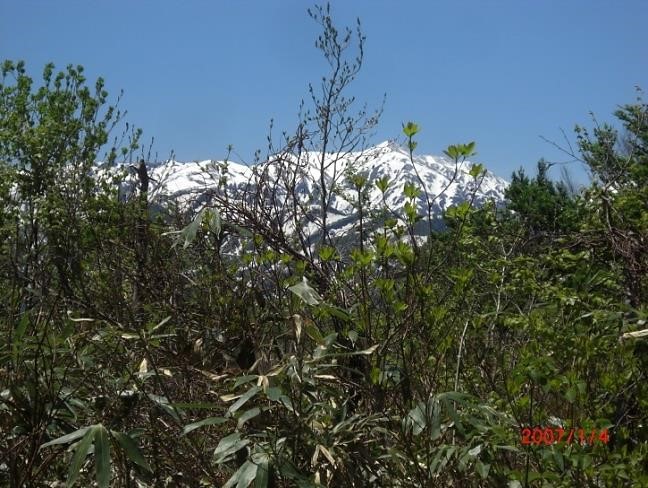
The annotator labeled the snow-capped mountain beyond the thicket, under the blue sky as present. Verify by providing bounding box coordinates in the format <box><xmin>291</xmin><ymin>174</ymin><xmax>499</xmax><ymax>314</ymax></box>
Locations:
<box><xmin>133</xmin><ymin>142</ymin><xmax>507</xmax><ymax>237</ymax></box>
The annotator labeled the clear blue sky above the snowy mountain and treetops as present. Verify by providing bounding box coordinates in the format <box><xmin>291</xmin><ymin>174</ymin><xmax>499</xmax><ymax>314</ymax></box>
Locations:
<box><xmin>0</xmin><ymin>0</ymin><xmax>648</xmax><ymax>180</ymax></box>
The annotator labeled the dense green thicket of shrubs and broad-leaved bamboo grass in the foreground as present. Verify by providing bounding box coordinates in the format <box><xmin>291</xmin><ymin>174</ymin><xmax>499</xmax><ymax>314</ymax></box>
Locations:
<box><xmin>0</xmin><ymin>8</ymin><xmax>648</xmax><ymax>487</ymax></box>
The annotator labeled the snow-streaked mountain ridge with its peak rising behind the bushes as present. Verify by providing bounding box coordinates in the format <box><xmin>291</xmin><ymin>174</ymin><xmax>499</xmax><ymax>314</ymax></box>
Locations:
<box><xmin>134</xmin><ymin>140</ymin><xmax>507</xmax><ymax>235</ymax></box>
